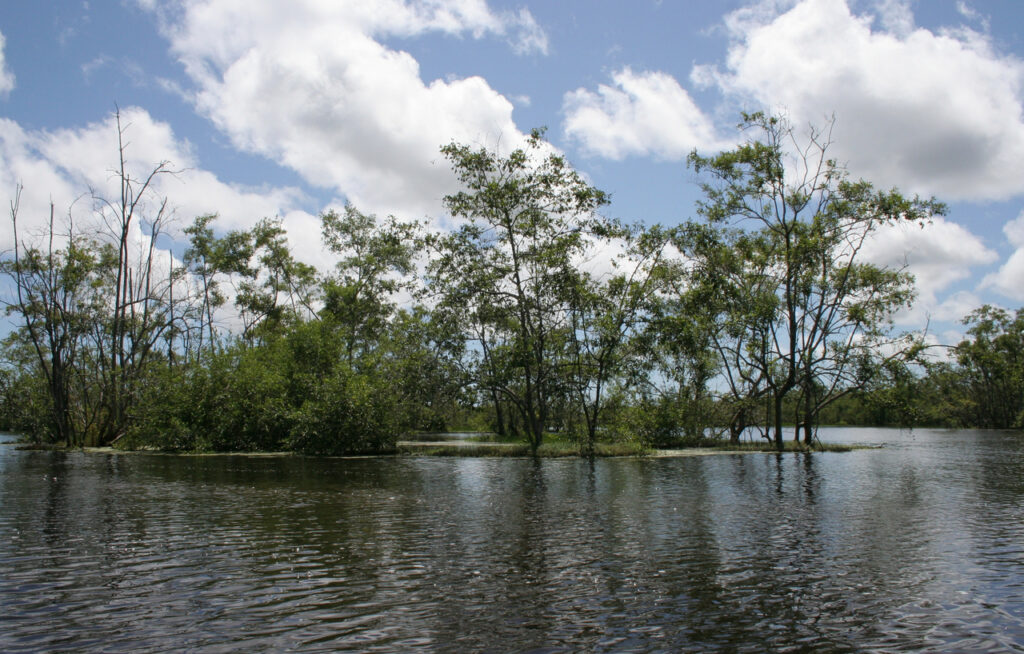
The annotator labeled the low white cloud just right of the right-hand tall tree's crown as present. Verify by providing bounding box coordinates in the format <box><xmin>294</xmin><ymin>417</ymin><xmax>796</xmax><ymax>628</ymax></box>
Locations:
<box><xmin>862</xmin><ymin>217</ymin><xmax>996</xmax><ymax>325</ymax></box>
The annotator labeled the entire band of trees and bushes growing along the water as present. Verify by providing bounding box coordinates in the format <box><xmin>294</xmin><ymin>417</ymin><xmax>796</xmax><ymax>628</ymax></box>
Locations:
<box><xmin>0</xmin><ymin>114</ymin><xmax>1024</xmax><ymax>455</ymax></box>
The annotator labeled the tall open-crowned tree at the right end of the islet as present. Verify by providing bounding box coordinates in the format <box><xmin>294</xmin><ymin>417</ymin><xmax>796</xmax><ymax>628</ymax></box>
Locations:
<box><xmin>689</xmin><ymin>113</ymin><xmax>944</xmax><ymax>448</ymax></box>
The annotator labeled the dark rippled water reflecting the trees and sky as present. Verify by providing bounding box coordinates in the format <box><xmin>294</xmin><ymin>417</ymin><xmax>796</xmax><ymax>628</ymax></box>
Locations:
<box><xmin>0</xmin><ymin>430</ymin><xmax>1024</xmax><ymax>652</ymax></box>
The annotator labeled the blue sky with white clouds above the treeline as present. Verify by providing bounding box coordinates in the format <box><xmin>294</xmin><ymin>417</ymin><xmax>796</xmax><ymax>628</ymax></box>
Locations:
<box><xmin>0</xmin><ymin>0</ymin><xmax>1024</xmax><ymax>343</ymax></box>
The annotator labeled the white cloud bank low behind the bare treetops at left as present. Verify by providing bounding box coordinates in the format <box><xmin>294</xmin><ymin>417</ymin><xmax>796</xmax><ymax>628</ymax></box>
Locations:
<box><xmin>0</xmin><ymin>107</ymin><xmax>329</xmax><ymax>266</ymax></box>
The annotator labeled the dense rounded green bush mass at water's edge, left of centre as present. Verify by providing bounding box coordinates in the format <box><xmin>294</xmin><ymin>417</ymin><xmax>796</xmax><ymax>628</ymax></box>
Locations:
<box><xmin>126</xmin><ymin>323</ymin><xmax>406</xmax><ymax>454</ymax></box>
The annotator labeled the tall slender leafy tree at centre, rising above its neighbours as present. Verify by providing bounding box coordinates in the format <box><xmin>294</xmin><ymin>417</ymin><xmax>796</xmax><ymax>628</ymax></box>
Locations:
<box><xmin>430</xmin><ymin>130</ymin><xmax>607</xmax><ymax>453</ymax></box>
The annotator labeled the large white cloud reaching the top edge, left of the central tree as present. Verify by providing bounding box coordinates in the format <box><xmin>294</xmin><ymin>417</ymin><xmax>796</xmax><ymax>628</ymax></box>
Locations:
<box><xmin>146</xmin><ymin>0</ymin><xmax>547</xmax><ymax>217</ymax></box>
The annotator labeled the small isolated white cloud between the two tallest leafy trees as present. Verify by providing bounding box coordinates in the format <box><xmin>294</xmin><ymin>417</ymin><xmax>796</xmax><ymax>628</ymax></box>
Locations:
<box><xmin>562</xmin><ymin>68</ymin><xmax>723</xmax><ymax>160</ymax></box>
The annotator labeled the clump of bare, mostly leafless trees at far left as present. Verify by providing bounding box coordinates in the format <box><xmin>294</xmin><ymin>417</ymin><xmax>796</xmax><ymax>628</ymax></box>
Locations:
<box><xmin>2</xmin><ymin>114</ymin><xmax>187</xmax><ymax>446</ymax></box>
